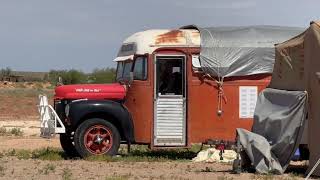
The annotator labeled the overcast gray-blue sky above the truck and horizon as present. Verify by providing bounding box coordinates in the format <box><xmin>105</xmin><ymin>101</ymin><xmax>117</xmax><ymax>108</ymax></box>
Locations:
<box><xmin>0</xmin><ymin>0</ymin><xmax>320</xmax><ymax>72</ymax></box>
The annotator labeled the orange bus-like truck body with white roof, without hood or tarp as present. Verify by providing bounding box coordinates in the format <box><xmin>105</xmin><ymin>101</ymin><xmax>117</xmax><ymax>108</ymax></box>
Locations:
<box><xmin>115</xmin><ymin>29</ymin><xmax>270</xmax><ymax>148</ymax></box>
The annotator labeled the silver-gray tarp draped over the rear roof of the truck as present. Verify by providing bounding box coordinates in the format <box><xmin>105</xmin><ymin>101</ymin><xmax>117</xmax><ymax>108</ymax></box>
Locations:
<box><xmin>198</xmin><ymin>26</ymin><xmax>303</xmax><ymax>77</ymax></box>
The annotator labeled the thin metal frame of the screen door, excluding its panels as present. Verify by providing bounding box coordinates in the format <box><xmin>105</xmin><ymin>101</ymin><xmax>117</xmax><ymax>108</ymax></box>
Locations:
<box><xmin>153</xmin><ymin>54</ymin><xmax>187</xmax><ymax>146</ymax></box>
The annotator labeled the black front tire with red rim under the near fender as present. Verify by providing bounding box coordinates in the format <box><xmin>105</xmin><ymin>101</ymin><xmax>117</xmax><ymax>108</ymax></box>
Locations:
<box><xmin>74</xmin><ymin>118</ymin><xmax>120</xmax><ymax>157</ymax></box>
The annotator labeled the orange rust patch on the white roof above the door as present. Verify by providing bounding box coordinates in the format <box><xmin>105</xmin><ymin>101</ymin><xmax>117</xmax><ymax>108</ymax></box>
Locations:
<box><xmin>155</xmin><ymin>30</ymin><xmax>184</xmax><ymax>44</ymax></box>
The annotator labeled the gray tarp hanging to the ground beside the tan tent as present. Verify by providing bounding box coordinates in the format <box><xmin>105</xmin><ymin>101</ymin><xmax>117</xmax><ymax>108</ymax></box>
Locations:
<box><xmin>237</xmin><ymin>88</ymin><xmax>307</xmax><ymax>174</ymax></box>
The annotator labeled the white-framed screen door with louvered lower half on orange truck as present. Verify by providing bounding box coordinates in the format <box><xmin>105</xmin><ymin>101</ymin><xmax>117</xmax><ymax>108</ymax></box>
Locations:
<box><xmin>153</xmin><ymin>55</ymin><xmax>186</xmax><ymax>146</ymax></box>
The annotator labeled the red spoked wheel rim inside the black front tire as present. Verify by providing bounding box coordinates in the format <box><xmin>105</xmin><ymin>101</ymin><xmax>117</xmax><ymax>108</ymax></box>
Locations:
<box><xmin>84</xmin><ymin>125</ymin><xmax>113</xmax><ymax>155</ymax></box>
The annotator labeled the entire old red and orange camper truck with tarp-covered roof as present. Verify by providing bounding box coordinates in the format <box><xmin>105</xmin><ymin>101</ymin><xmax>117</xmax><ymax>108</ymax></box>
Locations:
<box><xmin>39</xmin><ymin>26</ymin><xmax>300</xmax><ymax>157</ymax></box>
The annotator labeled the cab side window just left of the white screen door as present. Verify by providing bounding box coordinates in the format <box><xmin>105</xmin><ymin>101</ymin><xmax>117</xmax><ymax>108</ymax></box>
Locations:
<box><xmin>133</xmin><ymin>57</ymin><xmax>148</xmax><ymax>80</ymax></box>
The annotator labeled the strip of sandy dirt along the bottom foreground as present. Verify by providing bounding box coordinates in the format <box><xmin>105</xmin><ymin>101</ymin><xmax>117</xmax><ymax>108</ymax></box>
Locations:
<box><xmin>1</xmin><ymin>158</ymin><xmax>304</xmax><ymax>180</ymax></box>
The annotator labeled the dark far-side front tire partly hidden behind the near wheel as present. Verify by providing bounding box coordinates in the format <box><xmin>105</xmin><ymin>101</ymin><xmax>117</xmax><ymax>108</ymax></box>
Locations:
<box><xmin>60</xmin><ymin>133</ymin><xmax>79</xmax><ymax>157</ymax></box>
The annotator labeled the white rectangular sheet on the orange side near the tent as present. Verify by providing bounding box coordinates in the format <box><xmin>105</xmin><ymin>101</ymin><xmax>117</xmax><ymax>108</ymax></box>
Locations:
<box><xmin>239</xmin><ymin>86</ymin><xmax>258</xmax><ymax>118</ymax></box>
